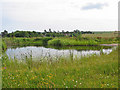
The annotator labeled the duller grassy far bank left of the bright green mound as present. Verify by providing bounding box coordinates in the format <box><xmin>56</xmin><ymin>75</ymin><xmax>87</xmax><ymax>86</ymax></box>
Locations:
<box><xmin>3</xmin><ymin>37</ymin><xmax>52</xmax><ymax>46</ymax></box>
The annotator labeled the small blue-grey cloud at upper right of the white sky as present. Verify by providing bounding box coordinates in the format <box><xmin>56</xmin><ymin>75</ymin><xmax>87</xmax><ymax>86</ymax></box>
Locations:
<box><xmin>81</xmin><ymin>3</ymin><xmax>108</xmax><ymax>10</ymax></box>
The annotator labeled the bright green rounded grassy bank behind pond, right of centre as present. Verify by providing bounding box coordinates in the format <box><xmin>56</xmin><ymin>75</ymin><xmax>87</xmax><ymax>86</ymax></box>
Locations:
<box><xmin>48</xmin><ymin>37</ymin><xmax>118</xmax><ymax>46</ymax></box>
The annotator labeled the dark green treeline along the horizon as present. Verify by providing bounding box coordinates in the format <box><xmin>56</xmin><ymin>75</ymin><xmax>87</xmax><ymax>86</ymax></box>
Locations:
<box><xmin>1</xmin><ymin>29</ymin><xmax>93</xmax><ymax>37</ymax></box>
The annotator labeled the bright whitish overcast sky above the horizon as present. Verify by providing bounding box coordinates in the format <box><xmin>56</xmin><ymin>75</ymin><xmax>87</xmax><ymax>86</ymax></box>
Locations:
<box><xmin>0</xmin><ymin>0</ymin><xmax>119</xmax><ymax>32</ymax></box>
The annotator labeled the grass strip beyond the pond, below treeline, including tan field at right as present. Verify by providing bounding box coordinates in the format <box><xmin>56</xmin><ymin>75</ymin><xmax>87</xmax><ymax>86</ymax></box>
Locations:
<box><xmin>3</xmin><ymin>33</ymin><xmax>120</xmax><ymax>46</ymax></box>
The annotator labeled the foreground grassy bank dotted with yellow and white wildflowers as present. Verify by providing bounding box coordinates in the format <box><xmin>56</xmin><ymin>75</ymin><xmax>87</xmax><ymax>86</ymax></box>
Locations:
<box><xmin>2</xmin><ymin>47</ymin><xmax>118</xmax><ymax>88</ymax></box>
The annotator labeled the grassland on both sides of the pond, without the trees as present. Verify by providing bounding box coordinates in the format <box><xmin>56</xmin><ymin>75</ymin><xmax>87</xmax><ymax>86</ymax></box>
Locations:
<box><xmin>1</xmin><ymin>33</ymin><xmax>119</xmax><ymax>88</ymax></box>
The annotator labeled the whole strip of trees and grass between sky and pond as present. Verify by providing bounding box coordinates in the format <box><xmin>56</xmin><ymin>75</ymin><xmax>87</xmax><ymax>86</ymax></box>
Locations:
<box><xmin>2</xmin><ymin>29</ymin><xmax>120</xmax><ymax>46</ymax></box>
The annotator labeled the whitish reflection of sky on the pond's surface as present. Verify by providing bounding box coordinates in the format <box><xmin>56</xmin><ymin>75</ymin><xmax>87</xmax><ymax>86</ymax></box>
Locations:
<box><xmin>6</xmin><ymin>46</ymin><xmax>116</xmax><ymax>59</ymax></box>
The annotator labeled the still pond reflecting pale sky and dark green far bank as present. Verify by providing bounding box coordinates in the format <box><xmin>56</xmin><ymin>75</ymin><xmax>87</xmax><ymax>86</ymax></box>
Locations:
<box><xmin>6</xmin><ymin>46</ymin><xmax>116</xmax><ymax>60</ymax></box>
